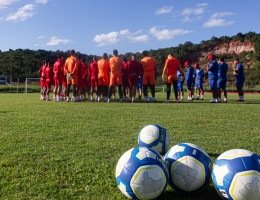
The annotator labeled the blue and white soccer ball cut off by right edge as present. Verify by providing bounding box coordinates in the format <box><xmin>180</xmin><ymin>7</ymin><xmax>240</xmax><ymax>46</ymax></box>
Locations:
<box><xmin>212</xmin><ymin>149</ymin><xmax>260</xmax><ymax>200</ymax></box>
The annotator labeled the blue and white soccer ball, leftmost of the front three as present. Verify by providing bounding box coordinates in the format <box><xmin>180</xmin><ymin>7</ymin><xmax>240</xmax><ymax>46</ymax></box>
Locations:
<box><xmin>116</xmin><ymin>147</ymin><xmax>168</xmax><ymax>199</ymax></box>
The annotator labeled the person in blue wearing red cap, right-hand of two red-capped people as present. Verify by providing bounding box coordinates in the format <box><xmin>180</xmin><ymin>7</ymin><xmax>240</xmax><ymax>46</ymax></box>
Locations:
<box><xmin>208</xmin><ymin>54</ymin><xmax>219</xmax><ymax>103</ymax></box>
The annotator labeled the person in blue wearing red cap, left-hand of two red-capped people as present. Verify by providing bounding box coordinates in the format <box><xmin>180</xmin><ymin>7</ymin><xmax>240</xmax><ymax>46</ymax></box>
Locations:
<box><xmin>184</xmin><ymin>60</ymin><xmax>195</xmax><ymax>101</ymax></box>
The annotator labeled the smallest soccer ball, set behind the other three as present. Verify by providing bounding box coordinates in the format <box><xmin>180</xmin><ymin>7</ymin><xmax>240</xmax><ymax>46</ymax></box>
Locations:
<box><xmin>138</xmin><ymin>124</ymin><xmax>170</xmax><ymax>154</ymax></box>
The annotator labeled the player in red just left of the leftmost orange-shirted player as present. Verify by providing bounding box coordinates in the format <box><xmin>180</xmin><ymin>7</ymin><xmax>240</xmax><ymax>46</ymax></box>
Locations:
<box><xmin>53</xmin><ymin>56</ymin><xmax>64</xmax><ymax>101</ymax></box>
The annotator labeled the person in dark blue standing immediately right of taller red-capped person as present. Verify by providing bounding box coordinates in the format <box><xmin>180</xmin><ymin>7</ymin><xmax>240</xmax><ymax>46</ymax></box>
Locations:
<box><xmin>218</xmin><ymin>58</ymin><xmax>228</xmax><ymax>103</ymax></box>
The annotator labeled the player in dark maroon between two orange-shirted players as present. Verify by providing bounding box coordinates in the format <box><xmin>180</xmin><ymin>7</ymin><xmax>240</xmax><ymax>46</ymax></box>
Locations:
<box><xmin>129</xmin><ymin>55</ymin><xmax>143</xmax><ymax>102</ymax></box>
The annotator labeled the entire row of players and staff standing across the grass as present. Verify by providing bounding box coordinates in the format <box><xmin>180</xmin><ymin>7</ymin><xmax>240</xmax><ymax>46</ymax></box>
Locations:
<box><xmin>39</xmin><ymin>50</ymin><xmax>245</xmax><ymax>103</ymax></box>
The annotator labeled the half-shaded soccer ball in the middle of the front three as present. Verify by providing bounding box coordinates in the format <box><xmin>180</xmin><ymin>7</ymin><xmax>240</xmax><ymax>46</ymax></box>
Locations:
<box><xmin>164</xmin><ymin>143</ymin><xmax>212</xmax><ymax>193</ymax></box>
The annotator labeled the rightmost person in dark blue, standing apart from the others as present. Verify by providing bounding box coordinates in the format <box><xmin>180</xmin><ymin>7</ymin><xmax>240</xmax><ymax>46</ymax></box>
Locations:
<box><xmin>233</xmin><ymin>58</ymin><xmax>245</xmax><ymax>102</ymax></box>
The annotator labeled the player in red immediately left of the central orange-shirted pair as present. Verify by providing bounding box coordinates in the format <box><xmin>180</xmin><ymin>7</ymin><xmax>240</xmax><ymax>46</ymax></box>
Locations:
<box><xmin>89</xmin><ymin>57</ymin><xmax>98</xmax><ymax>101</ymax></box>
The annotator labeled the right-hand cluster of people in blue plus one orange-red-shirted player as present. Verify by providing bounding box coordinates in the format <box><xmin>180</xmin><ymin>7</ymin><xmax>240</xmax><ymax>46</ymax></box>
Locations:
<box><xmin>162</xmin><ymin>54</ymin><xmax>245</xmax><ymax>103</ymax></box>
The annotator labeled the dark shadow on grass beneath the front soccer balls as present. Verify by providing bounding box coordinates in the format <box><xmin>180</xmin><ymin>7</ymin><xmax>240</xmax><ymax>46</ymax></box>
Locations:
<box><xmin>158</xmin><ymin>186</ymin><xmax>221</xmax><ymax>200</ymax></box>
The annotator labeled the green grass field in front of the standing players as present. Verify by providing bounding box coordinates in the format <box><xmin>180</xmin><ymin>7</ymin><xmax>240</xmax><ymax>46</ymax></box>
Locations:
<box><xmin>0</xmin><ymin>94</ymin><xmax>260</xmax><ymax>200</ymax></box>
